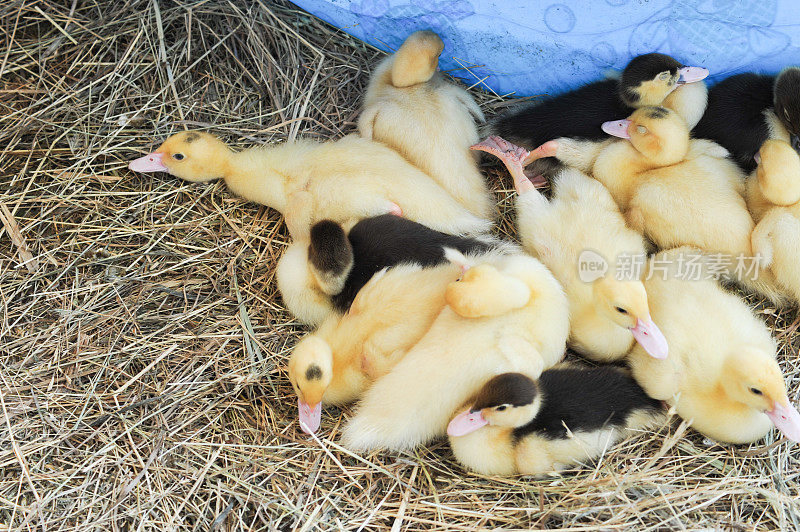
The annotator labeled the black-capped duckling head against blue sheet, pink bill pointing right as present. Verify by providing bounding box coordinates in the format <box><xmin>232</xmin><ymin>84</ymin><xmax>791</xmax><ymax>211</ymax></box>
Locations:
<box><xmin>617</xmin><ymin>53</ymin><xmax>708</xmax><ymax>107</ymax></box>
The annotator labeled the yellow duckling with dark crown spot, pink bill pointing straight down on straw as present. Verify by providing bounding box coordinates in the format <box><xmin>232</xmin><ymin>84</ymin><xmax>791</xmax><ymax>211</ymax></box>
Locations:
<box><xmin>288</xmin><ymin>263</ymin><xmax>461</xmax><ymax>433</ymax></box>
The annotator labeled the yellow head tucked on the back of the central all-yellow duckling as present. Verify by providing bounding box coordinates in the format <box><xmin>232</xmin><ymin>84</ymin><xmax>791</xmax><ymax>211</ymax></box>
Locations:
<box><xmin>445</xmin><ymin>264</ymin><xmax>531</xmax><ymax>318</ymax></box>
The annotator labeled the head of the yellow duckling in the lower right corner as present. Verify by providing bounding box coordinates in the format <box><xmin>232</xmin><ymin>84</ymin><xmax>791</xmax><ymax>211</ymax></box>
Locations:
<box><xmin>721</xmin><ymin>345</ymin><xmax>800</xmax><ymax>442</ymax></box>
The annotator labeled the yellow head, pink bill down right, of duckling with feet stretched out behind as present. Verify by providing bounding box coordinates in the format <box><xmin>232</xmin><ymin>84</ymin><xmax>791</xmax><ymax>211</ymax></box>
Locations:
<box><xmin>592</xmin><ymin>275</ymin><xmax>669</xmax><ymax>359</ymax></box>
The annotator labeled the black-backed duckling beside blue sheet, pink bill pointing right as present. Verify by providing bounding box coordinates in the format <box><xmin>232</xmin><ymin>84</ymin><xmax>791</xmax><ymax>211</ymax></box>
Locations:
<box><xmin>487</xmin><ymin>53</ymin><xmax>708</xmax><ymax>179</ymax></box>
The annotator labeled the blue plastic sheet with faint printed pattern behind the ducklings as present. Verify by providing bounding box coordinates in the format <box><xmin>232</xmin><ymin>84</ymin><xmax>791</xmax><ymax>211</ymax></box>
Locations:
<box><xmin>294</xmin><ymin>0</ymin><xmax>800</xmax><ymax>96</ymax></box>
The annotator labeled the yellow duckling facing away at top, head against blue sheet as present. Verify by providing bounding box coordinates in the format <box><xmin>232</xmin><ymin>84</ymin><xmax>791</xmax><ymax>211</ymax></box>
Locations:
<box><xmin>358</xmin><ymin>31</ymin><xmax>495</xmax><ymax>218</ymax></box>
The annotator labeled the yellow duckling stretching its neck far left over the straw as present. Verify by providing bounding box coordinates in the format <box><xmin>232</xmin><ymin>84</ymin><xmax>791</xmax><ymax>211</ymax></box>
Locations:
<box><xmin>130</xmin><ymin>132</ymin><xmax>490</xmax><ymax>238</ymax></box>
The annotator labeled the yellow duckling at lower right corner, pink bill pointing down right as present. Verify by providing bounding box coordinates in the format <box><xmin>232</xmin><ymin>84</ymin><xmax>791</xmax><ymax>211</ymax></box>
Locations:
<box><xmin>628</xmin><ymin>248</ymin><xmax>800</xmax><ymax>443</ymax></box>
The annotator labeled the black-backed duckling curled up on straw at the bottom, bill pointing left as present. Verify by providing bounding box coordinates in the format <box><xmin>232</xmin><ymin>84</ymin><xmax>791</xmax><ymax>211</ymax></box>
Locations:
<box><xmin>447</xmin><ymin>366</ymin><xmax>664</xmax><ymax>475</ymax></box>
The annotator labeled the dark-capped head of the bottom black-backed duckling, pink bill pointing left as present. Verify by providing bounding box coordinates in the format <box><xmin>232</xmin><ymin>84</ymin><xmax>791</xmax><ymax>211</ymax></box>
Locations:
<box><xmin>447</xmin><ymin>373</ymin><xmax>542</xmax><ymax>436</ymax></box>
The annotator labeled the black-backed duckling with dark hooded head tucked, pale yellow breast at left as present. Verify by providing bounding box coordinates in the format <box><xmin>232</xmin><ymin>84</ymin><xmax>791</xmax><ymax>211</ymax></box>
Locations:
<box><xmin>277</xmin><ymin>214</ymin><xmax>517</xmax><ymax>325</ymax></box>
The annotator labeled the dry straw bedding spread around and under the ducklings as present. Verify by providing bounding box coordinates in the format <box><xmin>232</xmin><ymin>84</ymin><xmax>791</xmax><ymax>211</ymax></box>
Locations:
<box><xmin>0</xmin><ymin>0</ymin><xmax>800</xmax><ymax>531</ymax></box>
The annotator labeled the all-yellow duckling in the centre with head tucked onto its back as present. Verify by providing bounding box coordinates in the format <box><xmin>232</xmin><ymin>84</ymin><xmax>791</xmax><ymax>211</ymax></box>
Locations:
<box><xmin>342</xmin><ymin>254</ymin><xmax>569</xmax><ymax>450</ymax></box>
